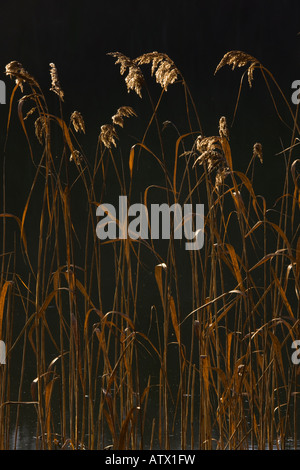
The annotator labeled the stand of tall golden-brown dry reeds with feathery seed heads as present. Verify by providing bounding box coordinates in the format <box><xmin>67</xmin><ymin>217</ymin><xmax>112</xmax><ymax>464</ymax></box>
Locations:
<box><xmin>0</xmin><ymin>51</ymin><xmax>300</xmax><ymax>449</ymax></box>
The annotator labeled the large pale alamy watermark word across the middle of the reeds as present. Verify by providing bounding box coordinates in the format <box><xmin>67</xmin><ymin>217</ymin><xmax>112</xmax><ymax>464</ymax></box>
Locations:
<box><xmin>96</xmin><ymin>196</ymin><xmax>204</xmax><ymax>250</ymax></box>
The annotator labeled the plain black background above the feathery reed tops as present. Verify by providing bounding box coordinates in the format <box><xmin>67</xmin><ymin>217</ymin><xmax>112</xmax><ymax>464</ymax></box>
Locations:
<box><xmin>0</xmin><ymin>0</ymin><xmax>300</xmax><ymax>202</ymax></box>
